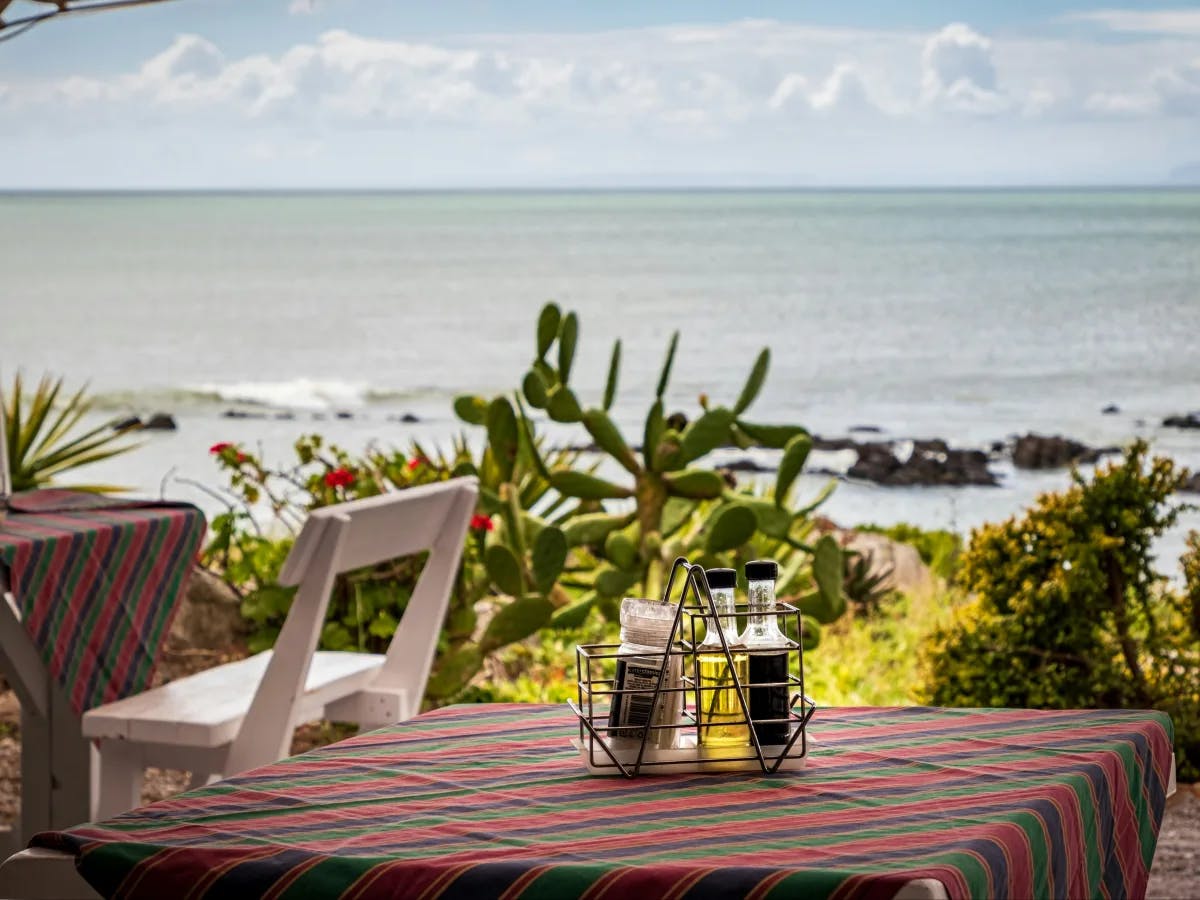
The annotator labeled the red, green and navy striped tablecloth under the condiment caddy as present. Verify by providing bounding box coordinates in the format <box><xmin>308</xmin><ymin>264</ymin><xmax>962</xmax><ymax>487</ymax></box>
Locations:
<box><xmin>34</xmin><ymin>704</ymin><xmax>1171</xmax><ymax>900</ymax></box>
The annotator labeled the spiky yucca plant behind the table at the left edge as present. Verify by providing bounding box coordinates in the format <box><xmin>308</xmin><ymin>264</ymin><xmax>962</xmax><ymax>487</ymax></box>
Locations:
<box><xmin>0</xmin><ymin>372</ymin><xmax>138</xmax><ymax>493</ymax></box>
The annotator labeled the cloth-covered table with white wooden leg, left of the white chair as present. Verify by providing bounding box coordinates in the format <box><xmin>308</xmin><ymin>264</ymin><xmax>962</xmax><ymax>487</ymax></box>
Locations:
<box><xmin>0</xmin><ymin>490</ymin><xmax>206</xmax><ymax>845</ymax></box>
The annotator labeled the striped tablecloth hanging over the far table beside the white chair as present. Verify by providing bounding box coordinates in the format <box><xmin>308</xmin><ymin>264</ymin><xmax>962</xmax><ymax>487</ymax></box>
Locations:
<box><xmin>0</xmin><ymin>491</ymin><xmax>205</xmax><ymax>713</ymax></box>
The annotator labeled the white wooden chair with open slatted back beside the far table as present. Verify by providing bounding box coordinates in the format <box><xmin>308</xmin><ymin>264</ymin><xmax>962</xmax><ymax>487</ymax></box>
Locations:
<box><xmin>83</xmin><ymin>478</ymin><xmax>479</xmax><ymax>818</ymax></box>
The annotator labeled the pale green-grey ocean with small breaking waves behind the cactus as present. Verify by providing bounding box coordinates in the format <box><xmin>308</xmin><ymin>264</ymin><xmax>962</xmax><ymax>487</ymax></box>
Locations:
<box><xmin>0</xmin><ymin>190</ymin><xmax>1200</xmax><ymax>568</ymax></box>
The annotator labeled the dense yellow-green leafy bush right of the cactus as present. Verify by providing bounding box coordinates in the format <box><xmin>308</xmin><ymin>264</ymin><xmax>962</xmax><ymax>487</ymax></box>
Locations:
<box><xmin>922</xmin><ymin>442</ymin><xmax>1200</xmax><ymax>779</ymax></box>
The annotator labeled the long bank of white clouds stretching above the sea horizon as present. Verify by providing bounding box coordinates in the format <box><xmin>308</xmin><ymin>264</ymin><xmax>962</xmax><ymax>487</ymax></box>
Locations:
<box><xmin>0</xmin><ymin>18</ymin><xmax>1200</xmax><ymax>188</ymax></box>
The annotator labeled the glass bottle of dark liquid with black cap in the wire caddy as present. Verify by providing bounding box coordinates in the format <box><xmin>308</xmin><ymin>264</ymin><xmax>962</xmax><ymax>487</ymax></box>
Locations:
<box><xmin>742</xmin><ymin>559</ymin><xmax>790</xmax><ymax>745</ymax></box>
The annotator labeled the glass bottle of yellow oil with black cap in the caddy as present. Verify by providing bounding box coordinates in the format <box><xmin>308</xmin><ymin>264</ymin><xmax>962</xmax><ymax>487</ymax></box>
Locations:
<box><xmin>696</xmin><ymin>569</ymin><xmax>750</xmax><ymax>748</ymax></box>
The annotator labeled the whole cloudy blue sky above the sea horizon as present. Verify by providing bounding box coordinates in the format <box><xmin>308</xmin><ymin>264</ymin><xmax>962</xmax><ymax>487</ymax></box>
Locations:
<box><xmin>0</xmin><ymin>0</ymin><xmax>1200</xmax><ymax>188</ymax></box>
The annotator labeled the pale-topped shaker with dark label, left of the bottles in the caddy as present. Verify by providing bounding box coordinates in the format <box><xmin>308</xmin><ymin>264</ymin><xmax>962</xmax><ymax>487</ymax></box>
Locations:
<box><xmin>608</xmin><ymin>598</ymin><xmax>684</xmax><ymax>749</ymax></box>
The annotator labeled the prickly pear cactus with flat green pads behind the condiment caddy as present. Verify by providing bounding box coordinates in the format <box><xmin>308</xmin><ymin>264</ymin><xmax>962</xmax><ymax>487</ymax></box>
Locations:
<box><xmin>455</xmin><ymin>304</ymin><xmax>846</xmax><ymax>648</ymax></box>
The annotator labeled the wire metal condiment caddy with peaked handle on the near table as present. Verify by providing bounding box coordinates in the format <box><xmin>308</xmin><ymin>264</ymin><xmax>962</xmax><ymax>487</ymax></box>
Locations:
<box><xmin>568</xmin><ymin>557</ymin><xmax>816</xmax><ymax>778</ymax></box>
